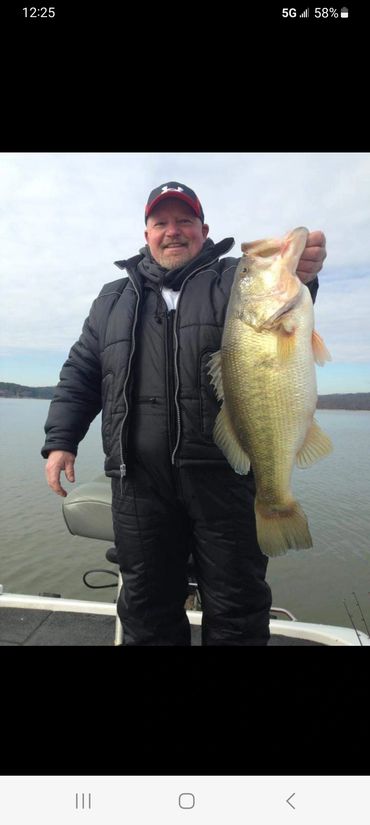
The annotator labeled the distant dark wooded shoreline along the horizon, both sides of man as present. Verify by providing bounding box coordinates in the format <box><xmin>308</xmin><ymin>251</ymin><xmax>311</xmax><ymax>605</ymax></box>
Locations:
<box><xmin>0</xmin><ymin>381</ymin><xmax>370</xmax><ymax>412</ymax></box>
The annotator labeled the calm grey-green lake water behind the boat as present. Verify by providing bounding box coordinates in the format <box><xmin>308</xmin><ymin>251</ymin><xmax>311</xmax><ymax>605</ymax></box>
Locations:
<box><xmin>0</xmin><ymin>398</ymin><xmax>370</xmax><ymax>630</ymax></box>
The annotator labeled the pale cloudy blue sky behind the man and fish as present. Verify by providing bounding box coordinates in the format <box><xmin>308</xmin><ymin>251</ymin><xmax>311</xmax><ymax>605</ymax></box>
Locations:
<box><xmin>0</xmin><ymin>152</ymin><xmax>370</xmax><ymax>394</ymax></box>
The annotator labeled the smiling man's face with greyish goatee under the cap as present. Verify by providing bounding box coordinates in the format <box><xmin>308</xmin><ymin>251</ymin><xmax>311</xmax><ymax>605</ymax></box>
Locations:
<box><xmin>145</xmin><ymin>198</ymin><xmax>209</xmax><ymax>269</ymax></box>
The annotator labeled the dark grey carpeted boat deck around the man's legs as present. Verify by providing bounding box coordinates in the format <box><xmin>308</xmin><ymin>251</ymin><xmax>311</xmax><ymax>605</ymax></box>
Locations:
<box><xmin>0</xmin><ymin>607</ymin><xmax>325</xmax><ymax>647</ymax></box>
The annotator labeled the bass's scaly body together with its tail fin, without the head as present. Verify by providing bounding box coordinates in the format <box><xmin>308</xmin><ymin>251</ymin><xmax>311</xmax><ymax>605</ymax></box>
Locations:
<box><xmin>221</xmin><ymin>318</ymin><xmax>317</xmax><ymax>555</ymax></box>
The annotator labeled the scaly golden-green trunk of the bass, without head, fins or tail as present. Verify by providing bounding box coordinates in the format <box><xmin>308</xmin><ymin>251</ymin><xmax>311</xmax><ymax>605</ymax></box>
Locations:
<box><xmin>221</xmin><ymin>321</ymin><xmax>317</xmax><ymax>503</ymax></box>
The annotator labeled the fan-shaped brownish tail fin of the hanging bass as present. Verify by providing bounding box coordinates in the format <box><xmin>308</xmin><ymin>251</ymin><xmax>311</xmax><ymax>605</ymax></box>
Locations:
<box><xmin>254</xmin><ymin>496</ymin><xmax>312</xmax><ymax>556</ymax></box>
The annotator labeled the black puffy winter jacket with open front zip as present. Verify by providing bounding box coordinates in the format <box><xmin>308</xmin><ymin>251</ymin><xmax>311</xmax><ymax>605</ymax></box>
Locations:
<box><xmin>41</xmin><ymin>239</ymin><xmax>318</xmax><ymax>478</ymax></box>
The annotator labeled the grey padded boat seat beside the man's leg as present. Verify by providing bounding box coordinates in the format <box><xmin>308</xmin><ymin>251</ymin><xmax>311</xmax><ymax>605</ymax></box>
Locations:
<box><xmin>62</xmin><ymin>475</ymin><xmax>114</xmax><ymax>542</ymax></box>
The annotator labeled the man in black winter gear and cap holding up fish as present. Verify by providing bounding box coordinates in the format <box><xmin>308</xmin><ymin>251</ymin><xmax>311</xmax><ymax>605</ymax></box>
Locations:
<box><xmin>42</xmin><ymin>181</ymin><xmax>326</xmax><ymax>645</ymax></box>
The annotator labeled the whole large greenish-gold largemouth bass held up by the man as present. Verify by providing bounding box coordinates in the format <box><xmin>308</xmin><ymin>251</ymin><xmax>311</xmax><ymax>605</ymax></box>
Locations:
<box><xmin>209</xmin><ymin>227</ymin><xmax>332</xmax><ymax>556</ymax></box>
